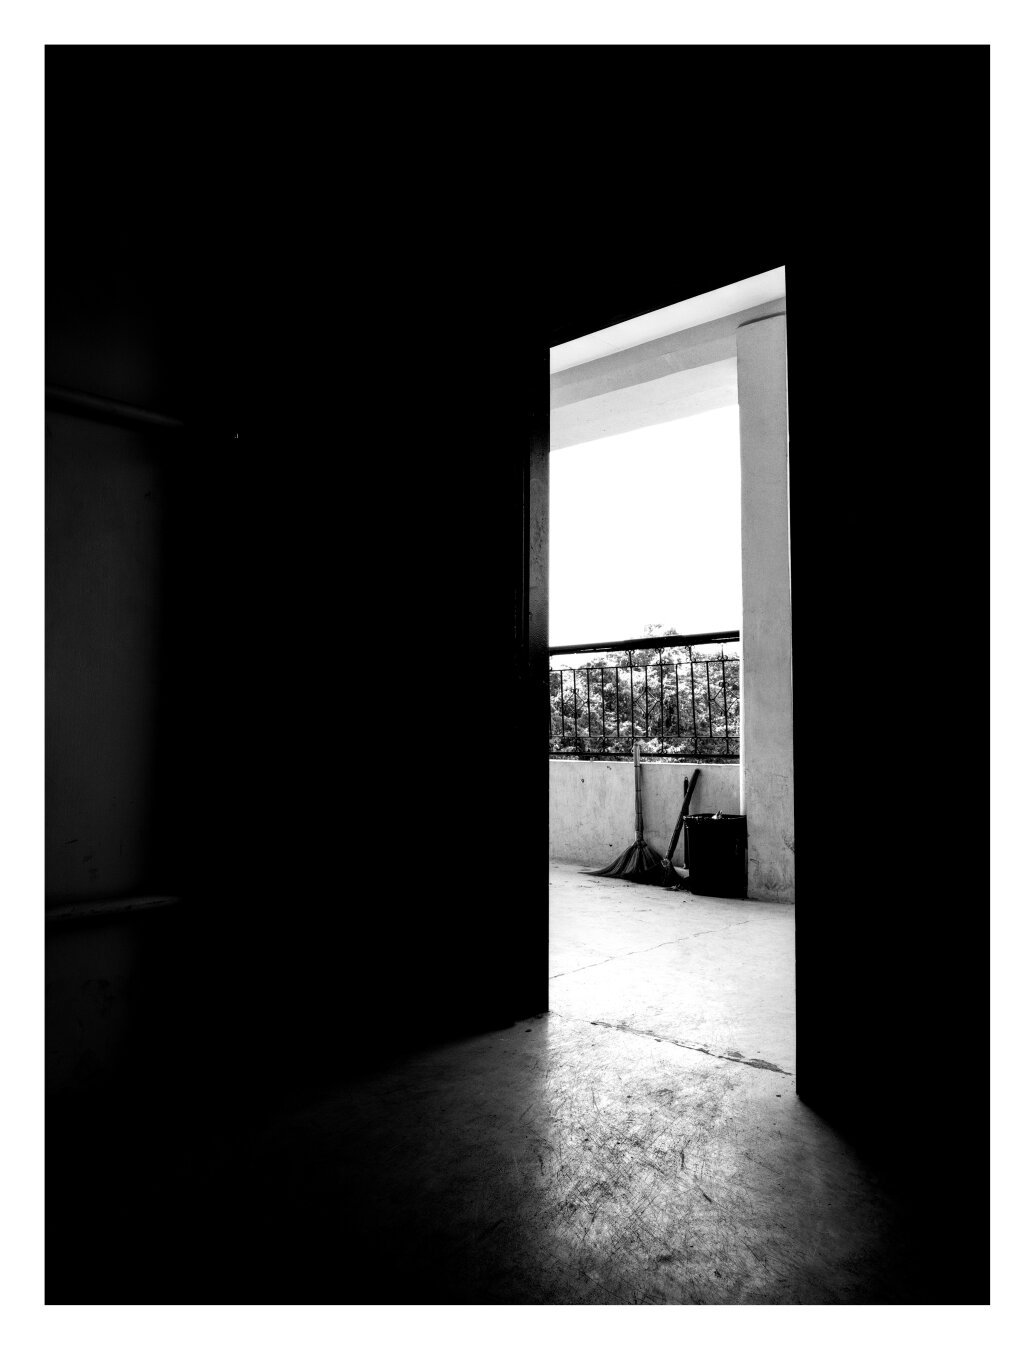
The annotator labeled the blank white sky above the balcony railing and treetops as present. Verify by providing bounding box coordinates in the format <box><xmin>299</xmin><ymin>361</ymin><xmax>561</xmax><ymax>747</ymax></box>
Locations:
<box><xmin>549</xmin><ymin>405</ymin><xmax>741</xmax><ymax>647</ymax></box>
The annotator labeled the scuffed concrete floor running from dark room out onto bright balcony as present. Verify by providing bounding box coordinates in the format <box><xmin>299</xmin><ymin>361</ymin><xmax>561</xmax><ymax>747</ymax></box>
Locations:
<box><xmin>52</xmin><ymin>864</ymin><xmax>933</xmax><ymax>1304</ymax></box>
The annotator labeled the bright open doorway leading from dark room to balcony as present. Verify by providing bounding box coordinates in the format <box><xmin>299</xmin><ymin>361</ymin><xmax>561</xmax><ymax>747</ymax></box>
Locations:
<box><xmin>549</xmin><ymin>269</ymin><xmax>795</xmax><ymax>1074</ymax></box>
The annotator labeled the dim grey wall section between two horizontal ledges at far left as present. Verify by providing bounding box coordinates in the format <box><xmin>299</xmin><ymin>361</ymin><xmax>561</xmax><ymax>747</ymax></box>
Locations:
<box><xmin>46</xmin><ymin>412</ymin><xmax>175</xmax><ymax>900</ymax></box>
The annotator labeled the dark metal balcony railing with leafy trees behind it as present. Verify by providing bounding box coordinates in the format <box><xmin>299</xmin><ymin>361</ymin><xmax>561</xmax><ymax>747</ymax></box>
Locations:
<box><xmin>549</xmin><ymin>629</ymin><xmax>741</xmax><ymax>763</ymax></box>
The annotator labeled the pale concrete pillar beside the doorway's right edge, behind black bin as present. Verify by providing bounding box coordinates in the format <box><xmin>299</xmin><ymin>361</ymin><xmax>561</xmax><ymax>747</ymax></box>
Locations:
<box><xmin>737</xmin><ymin>315</ymin><xmax>795</xmax><ymax>900</ymax></box>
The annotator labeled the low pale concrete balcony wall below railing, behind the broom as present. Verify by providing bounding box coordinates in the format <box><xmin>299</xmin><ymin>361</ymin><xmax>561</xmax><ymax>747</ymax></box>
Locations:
<box><xmin>549</xmin><ymin>760</ymin><xmax>750</xmax><ymax>867</ymax></box>
